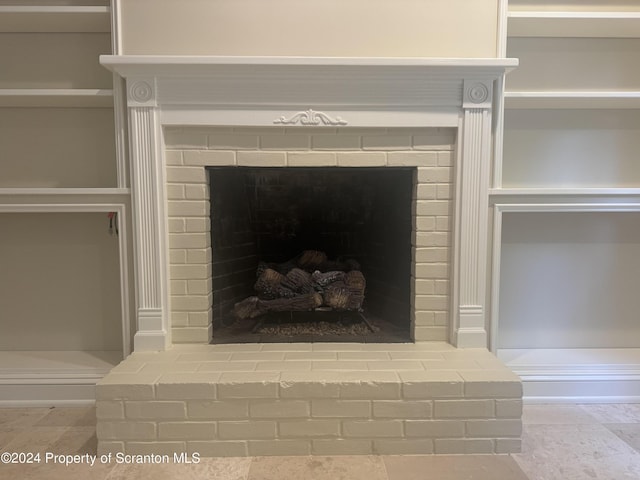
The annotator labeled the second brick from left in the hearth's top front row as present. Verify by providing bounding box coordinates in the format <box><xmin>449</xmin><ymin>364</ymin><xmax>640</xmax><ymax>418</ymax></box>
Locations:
<box><xmin>156</xmin><ymin>372</ymin><xmax>220</xmax><ymax>400</ymax></box>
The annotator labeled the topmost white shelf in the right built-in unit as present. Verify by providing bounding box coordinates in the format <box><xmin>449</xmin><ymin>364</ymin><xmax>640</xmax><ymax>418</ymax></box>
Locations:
<box><xmin>507</xmin><ymin>11</ymin><xmax>640</xmax><ymax>38</ymax></box>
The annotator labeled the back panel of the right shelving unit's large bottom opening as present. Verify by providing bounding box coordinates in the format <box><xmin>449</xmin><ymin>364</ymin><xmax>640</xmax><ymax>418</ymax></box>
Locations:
<box><xmin>498</xmin><ymin>213</ymin><xmax>640</xmax><ymax>348</ymax></box>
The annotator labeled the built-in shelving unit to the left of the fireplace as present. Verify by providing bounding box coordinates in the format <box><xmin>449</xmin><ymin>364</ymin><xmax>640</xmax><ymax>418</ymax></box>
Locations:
<box><xmin>0</xmin><ymin>0</ymin><xmax>131</xmax><ymax>406</ymax></box>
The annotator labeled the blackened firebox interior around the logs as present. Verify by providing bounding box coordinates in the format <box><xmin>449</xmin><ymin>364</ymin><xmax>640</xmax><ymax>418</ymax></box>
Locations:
<box><xmin>207</xmin><ymin>167</ymin><xmax>414</xmax><ymax>343</ymax></box>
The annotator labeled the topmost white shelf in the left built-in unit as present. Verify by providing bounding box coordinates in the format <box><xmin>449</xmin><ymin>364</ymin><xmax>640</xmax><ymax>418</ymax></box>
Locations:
<box><xmin>0</xmin><ymin>5</ymin><xmax>111</xmax><ymax>33</ymax></box>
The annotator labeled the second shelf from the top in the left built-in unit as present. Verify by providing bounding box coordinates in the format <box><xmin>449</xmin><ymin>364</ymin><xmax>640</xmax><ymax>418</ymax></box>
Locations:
<box><xmin>0</xmin><ymin>88</ymin><xmax>113</xmax><ymax>108</ymax></box>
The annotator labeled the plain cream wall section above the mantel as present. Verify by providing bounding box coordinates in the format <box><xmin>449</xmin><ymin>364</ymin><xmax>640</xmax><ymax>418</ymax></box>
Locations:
<box><xmin>122</xmin><ymin>0</ymin><xmax>498</xmax><ymax>57</ymax></box>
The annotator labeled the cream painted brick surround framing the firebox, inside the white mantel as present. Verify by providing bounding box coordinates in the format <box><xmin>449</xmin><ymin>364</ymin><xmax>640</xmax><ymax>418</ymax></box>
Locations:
<box><xmin>165</xmin><ymin>127</ymin><xmax>455</xmax><ymax>343</ymax></box>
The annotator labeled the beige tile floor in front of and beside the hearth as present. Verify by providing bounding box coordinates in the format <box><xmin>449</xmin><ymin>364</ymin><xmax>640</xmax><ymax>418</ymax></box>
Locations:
<box><xmin>0</xmin><ymin>404</ymin><xmax>640</xmax><ymax>480</ymax></box>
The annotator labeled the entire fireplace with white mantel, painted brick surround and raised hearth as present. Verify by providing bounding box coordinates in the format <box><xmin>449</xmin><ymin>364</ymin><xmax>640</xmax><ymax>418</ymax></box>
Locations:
<box><xmin>96</xmin><ymin>56</ymin><xmax>522</xmax><ymax>456</ymax></box>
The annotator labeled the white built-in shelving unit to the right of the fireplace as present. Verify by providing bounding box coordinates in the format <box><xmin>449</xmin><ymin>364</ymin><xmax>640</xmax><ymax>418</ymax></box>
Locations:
<box><xmin>498</xmin><ymin>0</ymin><xmax>640</xmax><ymax>402</ymax></box>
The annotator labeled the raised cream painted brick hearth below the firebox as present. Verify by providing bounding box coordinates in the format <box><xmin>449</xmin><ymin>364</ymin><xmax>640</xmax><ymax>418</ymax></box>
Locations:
<box><xmin>97</xmin><ymin>342</ymin><xmax>522</xmax><ymax>456</ymax></box>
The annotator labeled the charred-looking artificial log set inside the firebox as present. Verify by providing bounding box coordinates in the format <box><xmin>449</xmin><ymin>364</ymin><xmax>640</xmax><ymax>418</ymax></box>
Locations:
<box><xmin>233</xmin><ymin>250</ymin><xmax>366</xmax><ymax>320</ymax></box>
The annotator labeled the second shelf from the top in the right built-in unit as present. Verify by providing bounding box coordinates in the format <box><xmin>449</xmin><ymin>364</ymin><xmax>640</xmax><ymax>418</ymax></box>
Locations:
<box><xmin>504</xmin><ymin>91</ymin><xmax>640</xmax><ymax>109</ymax></box>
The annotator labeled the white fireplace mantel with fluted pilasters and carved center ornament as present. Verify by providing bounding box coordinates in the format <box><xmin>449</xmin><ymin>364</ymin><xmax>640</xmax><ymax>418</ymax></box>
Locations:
<box><xmin>100</xmin><ymin>56</ymin><xmax>518</xmax><ymax>351</ymax></box>
